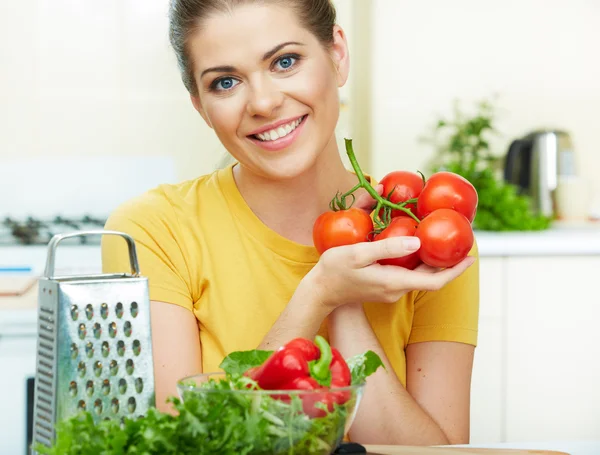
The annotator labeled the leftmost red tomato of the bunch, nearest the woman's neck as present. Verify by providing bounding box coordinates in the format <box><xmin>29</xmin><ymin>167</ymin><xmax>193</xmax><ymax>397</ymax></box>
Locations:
<box><xmin>313</xmin><ymin>207</ymin><xmax>373</xmax><ymax>254</ymax></box>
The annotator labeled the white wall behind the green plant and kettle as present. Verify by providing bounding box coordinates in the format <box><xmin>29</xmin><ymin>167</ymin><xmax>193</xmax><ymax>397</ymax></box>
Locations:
<box><xmin>371</xmin><ymin>0</ymin><xmax>600</xmax><ymax>213</ymax></box>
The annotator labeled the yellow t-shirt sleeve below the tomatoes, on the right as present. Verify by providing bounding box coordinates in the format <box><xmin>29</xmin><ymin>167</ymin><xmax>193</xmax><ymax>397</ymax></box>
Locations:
<box><xmin>408</xmin><ymin>243</ymin><xmax>479</xmax><ymax>346</ymax></box>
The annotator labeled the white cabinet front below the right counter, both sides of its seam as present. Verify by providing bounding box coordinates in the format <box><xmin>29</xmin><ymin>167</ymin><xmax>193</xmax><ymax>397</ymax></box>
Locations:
<box><xmin>471</xmin><ymin>255</ymin><xmax>600</xmax><ymax>444</ymax></box>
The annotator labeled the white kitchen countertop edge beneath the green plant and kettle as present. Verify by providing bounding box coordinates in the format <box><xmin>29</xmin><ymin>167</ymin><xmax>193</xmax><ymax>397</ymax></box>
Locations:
<box><xmin>475</xmin><ymin>222</ymin><xmax>600</xmax><ymax>257</ymax></box>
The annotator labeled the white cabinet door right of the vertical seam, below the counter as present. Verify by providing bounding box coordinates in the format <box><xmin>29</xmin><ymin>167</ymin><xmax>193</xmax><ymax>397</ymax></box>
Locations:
<box><xmin>506</xmin><ymin>256</ymin><xmax>600</xmax><ymax>441</ymax></box>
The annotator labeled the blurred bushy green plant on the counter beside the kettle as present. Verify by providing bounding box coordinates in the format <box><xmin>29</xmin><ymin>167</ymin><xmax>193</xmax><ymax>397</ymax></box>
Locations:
<box><xmin>425</xmin><ymin>100</ymin><xmax>552</xmax><ymax>231</ymax></box>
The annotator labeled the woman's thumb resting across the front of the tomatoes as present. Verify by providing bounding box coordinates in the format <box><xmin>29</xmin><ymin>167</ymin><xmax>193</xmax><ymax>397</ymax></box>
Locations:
<box><xmin>346</xmin><ymin>236</ymin><xmax>421</xmax><ymax>267</ymax></box>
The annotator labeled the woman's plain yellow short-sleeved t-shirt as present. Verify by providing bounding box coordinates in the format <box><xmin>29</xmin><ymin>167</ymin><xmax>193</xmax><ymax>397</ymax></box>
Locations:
<box><xmin>102</xmin><ymin>165</ymin><xmax>479</xmax><ymax>384</ymax></box>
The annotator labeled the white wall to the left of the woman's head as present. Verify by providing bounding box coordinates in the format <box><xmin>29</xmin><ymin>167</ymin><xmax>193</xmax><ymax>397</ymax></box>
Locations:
<box><xmin>0</xmin><ymin>0</ymin><xmax>226</xmax><ymax>183</ymax></box>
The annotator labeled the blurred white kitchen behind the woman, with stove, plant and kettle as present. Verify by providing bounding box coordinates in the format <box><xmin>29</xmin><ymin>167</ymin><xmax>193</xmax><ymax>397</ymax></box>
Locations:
<box><xmin>0</xmin><ymin>0</ymin><xmax>600</xmax><ymax>454</ymax></box>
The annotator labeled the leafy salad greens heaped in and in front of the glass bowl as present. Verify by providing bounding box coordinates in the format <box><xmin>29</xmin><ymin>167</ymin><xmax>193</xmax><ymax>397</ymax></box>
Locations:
<box><xmin>36</xmin><ymin>351</ymin><xmax>381</xmax><ymax>455</ymax></box>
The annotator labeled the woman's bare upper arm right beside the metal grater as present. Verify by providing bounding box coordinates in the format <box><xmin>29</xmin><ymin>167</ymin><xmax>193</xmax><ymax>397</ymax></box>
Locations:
<box><xmin>151</xmin><ymin>301</ymin><xmax>202</xmax><ymax>412</ymax></box>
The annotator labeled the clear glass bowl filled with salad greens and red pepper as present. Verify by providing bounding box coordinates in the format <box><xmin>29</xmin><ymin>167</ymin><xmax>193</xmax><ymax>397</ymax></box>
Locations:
<box><xmin>177</xmin><ymin>373</ymin><xmax>364</xmax><ymax>455</ymax></box>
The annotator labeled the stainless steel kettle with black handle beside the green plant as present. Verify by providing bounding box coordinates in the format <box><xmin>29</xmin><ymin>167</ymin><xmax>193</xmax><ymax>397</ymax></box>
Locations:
<box><xmin>504</xmin><ymin>130</ymin><xmax>576</xmax><ymax>217</ymax></box>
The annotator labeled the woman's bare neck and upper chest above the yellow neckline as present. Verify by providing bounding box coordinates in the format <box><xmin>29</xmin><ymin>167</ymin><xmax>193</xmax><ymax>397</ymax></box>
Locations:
<box><xmin>234</xmin><ymin>139</ymin><xmax>357</xmax><ymax>245</ymax></box>
